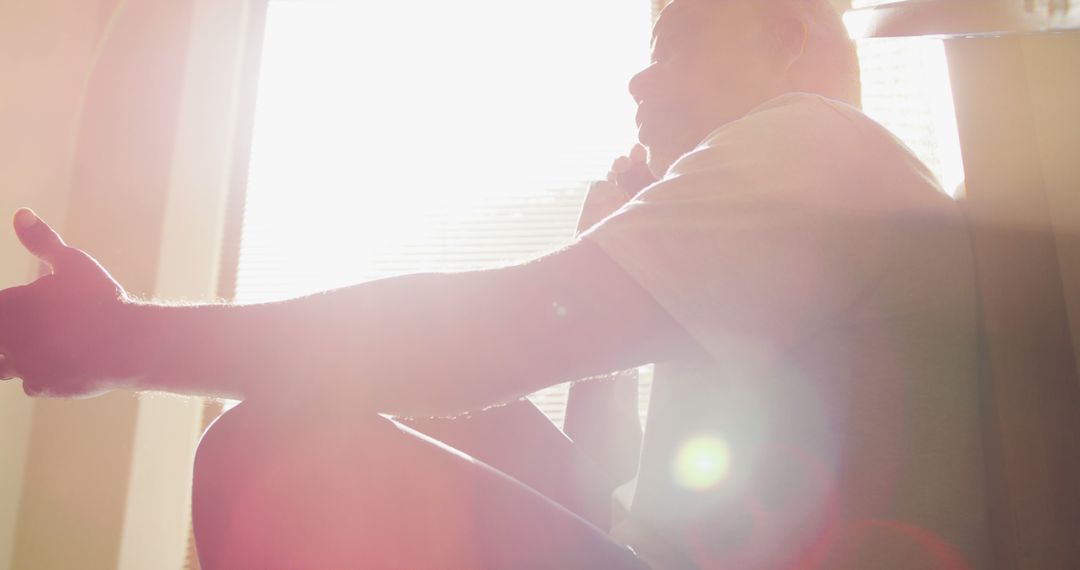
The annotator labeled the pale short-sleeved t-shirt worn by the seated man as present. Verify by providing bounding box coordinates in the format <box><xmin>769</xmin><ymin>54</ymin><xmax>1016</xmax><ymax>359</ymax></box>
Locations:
<box><xmin>583</xmin><ymin>94</ymin><xmax>987</xmax><ymax>569</ymax></box>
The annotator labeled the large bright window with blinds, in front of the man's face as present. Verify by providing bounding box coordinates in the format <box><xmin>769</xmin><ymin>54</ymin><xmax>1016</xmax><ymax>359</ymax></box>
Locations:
<box><xmin>237</xmin><ymin>0</ymin><xmax>653</xmax><ymax>423</ymax></box>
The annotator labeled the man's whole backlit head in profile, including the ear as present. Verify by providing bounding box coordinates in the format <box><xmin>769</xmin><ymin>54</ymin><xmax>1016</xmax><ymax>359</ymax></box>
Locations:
<box><xmin>630</xmin><ymin>0</ymin><xmax>860</xmax><ymax>177</ymax></box>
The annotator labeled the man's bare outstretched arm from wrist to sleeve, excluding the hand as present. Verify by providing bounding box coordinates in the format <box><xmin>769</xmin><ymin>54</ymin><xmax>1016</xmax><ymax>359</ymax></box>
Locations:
<box><xmin>109</xmin><ymin>244</ymin><xmax>690</xmax><ymax>413</ymax></box>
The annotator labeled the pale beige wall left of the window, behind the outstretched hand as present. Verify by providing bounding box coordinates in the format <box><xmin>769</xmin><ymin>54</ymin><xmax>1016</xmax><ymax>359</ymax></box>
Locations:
<box><xmin>0</xmin><ymin>0</ymin><xmax>247</xmax><ymax>569</ymax></box>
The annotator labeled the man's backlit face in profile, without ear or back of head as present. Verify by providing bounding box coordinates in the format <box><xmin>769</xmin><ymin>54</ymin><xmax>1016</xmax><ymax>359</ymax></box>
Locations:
<box><xmin>630</xmin><ymin>0</ymin><xmax>782</xmax><ymax>177</ymax></box>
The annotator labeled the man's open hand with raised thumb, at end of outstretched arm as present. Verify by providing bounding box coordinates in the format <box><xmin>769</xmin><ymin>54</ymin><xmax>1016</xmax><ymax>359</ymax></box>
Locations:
<box><xmin>0</xmin><ymin>208</ymin><xmax>126</xmax><ymax>397</ymax></box>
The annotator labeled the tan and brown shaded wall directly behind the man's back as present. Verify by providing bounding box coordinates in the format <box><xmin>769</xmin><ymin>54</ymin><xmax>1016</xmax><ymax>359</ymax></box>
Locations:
<box><xmin>946</xmin><ymin>31</ymin><xmax>1080</xmax><ymax>570</ymax></box>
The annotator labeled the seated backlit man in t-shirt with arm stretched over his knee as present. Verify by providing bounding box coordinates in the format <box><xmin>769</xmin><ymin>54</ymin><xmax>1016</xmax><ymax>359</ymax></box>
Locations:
<box><xmin>0</xmin><ymin>0</ymin><xmax>986</xmax><ymax>569</ymax></box>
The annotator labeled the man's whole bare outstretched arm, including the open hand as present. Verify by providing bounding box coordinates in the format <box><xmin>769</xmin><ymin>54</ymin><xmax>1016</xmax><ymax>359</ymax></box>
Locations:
<box><xmin>0</xmin><ymin>209</ymin><xmax>694</xmax><ymax>413</ymax></box>
